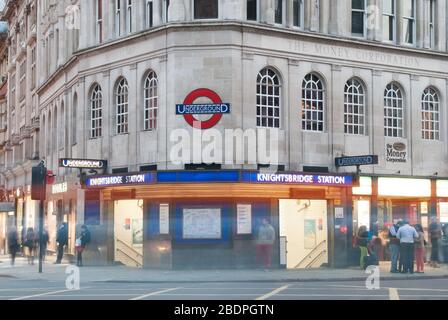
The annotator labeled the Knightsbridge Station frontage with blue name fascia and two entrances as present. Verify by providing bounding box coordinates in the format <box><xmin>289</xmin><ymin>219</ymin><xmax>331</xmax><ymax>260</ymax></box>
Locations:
<box><xmin>85</xmin><ymin>170</ymin><xmax>353</xmax><ymax>269</ymax></box>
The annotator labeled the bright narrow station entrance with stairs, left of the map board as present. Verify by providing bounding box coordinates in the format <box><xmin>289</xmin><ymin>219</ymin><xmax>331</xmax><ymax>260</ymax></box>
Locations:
<box><xmin>114</xmin><ymin>200</ymin><xmax>143</xmax><ymax>268</ymax></box>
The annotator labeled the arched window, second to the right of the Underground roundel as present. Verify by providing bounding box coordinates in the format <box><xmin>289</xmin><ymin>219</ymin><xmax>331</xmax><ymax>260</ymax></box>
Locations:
<box><xmin>302</xmin><ymin>73</ymin><xmax>325</xmax><ymax>132</ymax></box>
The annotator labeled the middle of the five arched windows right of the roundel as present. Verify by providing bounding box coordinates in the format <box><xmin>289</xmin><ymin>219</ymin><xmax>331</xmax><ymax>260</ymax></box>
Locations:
<box><xmin>344</xmin><ymin>79</ymin><xmax>366</xmax><ymax>135</ymax></box>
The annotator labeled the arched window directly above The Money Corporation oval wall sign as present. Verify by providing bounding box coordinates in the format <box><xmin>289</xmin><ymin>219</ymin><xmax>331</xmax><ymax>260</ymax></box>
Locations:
<box><xmin>384</xmin><ymin>83</ymin><xmax>403</xmax><ymax>138</ymax></box>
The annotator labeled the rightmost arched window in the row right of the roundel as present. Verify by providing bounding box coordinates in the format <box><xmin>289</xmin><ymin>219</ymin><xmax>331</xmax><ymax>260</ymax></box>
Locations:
<box><xmin>422</xmin><ymin>88</ymin><xmax>440</xmax><ymax>140</ymax></box>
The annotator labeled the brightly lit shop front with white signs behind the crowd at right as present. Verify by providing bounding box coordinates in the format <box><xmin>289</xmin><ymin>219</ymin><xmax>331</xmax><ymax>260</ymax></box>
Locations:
<box><xmin>352</xmin><ymin>176</ymin><xmax>448</xmax><ymax>263</ymax></box>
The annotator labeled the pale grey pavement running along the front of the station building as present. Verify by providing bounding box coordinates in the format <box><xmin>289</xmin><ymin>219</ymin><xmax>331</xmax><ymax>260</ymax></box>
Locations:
<box><xmin>0</xmin><ymin>257</ymin><xmax>448</xmax><ymax>283</ymax></box>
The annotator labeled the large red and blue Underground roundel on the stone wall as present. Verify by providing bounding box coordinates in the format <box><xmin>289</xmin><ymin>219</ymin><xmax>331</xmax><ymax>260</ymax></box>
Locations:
<box><xmin>176</xmin><ymin>88</ymin><xmax>230</xmax><ymax>130</ymax></box>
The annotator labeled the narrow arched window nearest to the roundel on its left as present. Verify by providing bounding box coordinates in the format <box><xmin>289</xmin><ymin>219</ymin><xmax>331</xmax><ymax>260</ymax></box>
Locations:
<box><xmin>143</xmin><ymin>71</ymin><xmax>158</xmax><ymax>130</ymax></box>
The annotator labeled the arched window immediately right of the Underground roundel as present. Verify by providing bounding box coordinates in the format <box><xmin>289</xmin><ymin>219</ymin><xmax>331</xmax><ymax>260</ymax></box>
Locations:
<box><xmin>257</xmin><ymin>68</ymin><xmax>281</xmax><ymax>128</ymax></box>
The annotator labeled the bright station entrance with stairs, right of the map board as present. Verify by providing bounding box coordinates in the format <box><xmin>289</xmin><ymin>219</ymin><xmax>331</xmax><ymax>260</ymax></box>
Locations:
<box><xmin>279</xmin><ymin>200</ymin><xmax>328</xmax><ymax>269</ymax></box>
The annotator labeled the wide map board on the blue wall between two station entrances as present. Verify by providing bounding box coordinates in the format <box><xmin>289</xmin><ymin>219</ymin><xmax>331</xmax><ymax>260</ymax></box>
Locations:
<box><xmin>182</xmin><ymin>208</ymin><xmax>222</xmax><ymax>239</ymax></box>
